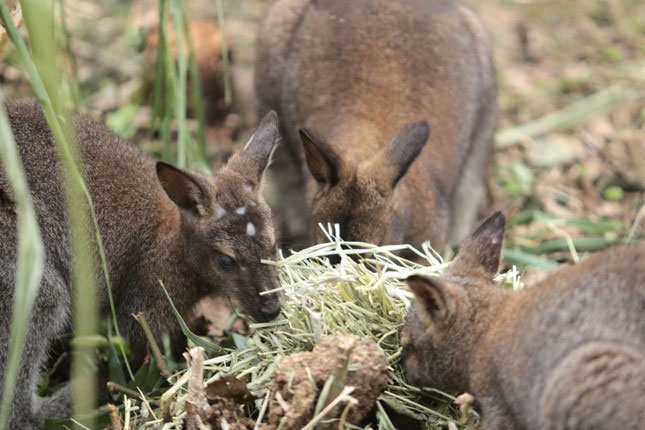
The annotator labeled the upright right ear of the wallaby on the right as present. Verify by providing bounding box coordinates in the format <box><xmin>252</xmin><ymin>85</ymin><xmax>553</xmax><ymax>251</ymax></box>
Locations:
<box><xmin>450</xmin><ymin>212</ymin><xmax>506</xmax><ymax>278</ymax></box>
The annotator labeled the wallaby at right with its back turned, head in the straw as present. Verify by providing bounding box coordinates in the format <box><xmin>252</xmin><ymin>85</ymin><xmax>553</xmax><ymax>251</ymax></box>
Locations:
<box><xmin>401</xmin><ymin>213</ymin><xmax>645</xmax><ymax>430</ymax></box>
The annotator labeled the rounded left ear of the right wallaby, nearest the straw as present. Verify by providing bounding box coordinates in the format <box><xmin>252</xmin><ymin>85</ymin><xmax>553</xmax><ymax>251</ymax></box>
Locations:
<box><xmin>407</xmin><ymin>275</ymin><xmax>455</xmax><ymax>322</ymax></box>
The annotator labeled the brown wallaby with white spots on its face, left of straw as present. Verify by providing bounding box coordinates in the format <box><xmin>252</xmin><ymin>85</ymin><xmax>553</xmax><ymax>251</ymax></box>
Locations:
<box><xmin>0</xmin><ymin>101</ymin><xmax>280</xmax><ymax>429</ymax></box>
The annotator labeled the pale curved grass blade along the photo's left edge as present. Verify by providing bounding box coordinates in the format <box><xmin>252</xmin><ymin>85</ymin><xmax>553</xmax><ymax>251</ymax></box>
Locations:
<box><xmin>0</xmin><ymin>85</ymin><xmax>44</xmax><ymax>428</ymax></box>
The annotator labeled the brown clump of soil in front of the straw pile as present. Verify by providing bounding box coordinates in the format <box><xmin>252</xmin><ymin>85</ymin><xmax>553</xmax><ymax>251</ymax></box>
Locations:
<box><xmin>260</xmin><ymin>336</ymin><xmax>388</xmax><ymax>430</ymax></box>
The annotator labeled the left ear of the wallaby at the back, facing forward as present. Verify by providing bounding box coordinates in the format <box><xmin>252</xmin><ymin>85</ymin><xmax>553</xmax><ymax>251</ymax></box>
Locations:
<box><xmin>299</xmin><ymin>129</ymin><xmax>339</xmax><ymax>186</ymax></box>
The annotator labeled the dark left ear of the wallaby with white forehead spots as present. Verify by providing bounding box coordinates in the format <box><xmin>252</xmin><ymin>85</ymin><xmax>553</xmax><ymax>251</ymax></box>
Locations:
<box><xmin>157</xmin><ymin>161</ymin><xmax>208</xmax><ymax>215</ymax></box>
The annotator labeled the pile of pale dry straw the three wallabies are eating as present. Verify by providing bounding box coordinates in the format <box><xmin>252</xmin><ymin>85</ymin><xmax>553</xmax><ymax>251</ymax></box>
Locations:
<box><xmin>123</xmin><ymin>226</ymin><xmax>521</xmax><ymax>429</ymax></box>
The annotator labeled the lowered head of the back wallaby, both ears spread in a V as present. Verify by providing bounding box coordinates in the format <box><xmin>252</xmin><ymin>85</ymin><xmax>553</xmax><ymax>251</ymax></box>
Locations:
<box><xmin>300</xmin><ymin>120</ymin><xmax>430</xmax><ymax>244</ymax></box>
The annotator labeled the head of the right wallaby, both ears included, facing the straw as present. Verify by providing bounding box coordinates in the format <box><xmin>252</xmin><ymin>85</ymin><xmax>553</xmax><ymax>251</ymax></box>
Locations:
<box><xmin>401</xmin><ymin>212</ymin><xmax>505</xmax><ymax>391</ymax></box>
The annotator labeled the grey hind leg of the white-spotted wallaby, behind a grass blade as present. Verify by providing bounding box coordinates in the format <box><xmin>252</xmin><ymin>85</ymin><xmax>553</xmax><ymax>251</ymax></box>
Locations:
<box><xmin>0</xmin><ymin>260</ymin><xmax>70</xmax><ymax>429</ymax></box>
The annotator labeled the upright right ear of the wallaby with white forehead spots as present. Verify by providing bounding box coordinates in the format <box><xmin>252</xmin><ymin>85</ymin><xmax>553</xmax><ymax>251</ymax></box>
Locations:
<box><xmin>229</xmin><ymin>111</ymin><xmax>280</xmax><ymax>184</ymax></box>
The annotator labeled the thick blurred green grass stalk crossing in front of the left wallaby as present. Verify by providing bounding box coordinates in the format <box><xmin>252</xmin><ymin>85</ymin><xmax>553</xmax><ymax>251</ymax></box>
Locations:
<box><xmin>0</xmin><ymin>0</ymin><xmax>97</xmax><ymax>425</ymax></box>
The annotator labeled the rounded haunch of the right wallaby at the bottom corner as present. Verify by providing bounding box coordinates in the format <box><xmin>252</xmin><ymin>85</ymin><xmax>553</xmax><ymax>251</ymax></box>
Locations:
<box><xmin>539</xmin><ymin>342</ymin><xmax>645</xmax><ymax>430</ymax></box>
